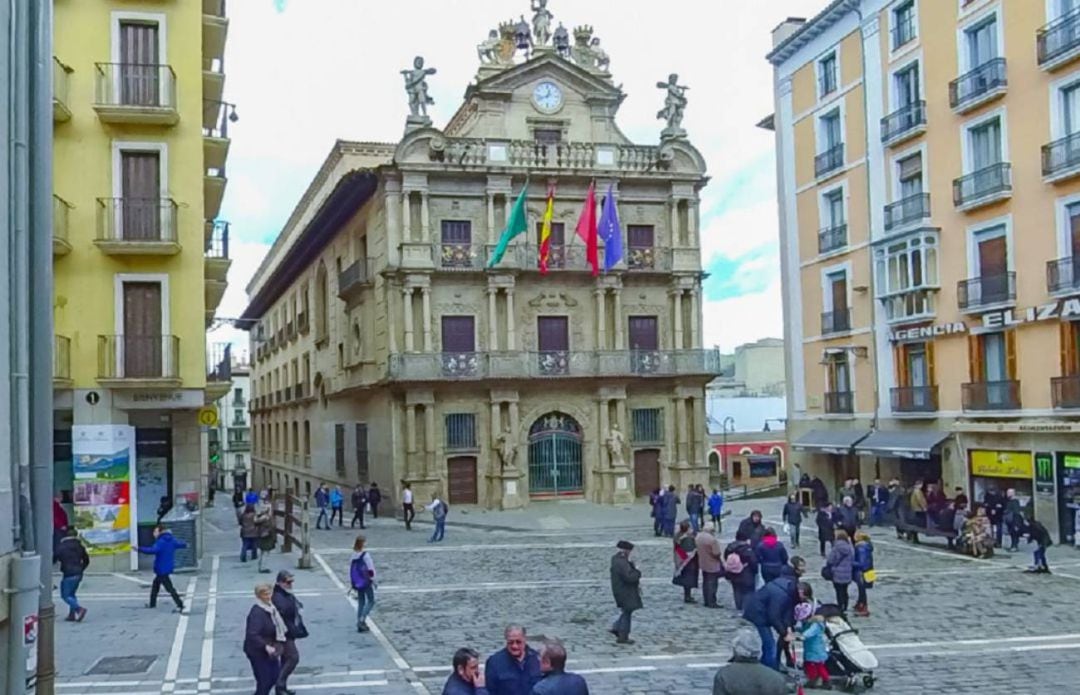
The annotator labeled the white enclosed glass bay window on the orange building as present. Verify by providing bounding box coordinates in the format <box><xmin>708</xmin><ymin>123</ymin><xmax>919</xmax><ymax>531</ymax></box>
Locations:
<box><xmin>874</xmin><ymin>232</ymin><xmax>939</xmax><ymax>321</ymax></box>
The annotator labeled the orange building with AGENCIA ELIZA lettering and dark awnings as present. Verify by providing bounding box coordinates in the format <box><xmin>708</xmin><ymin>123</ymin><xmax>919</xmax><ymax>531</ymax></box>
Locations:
<box><xmin>768</xmin><ymin>0</ymin><xmax>1080</xmax><ymax>542</ymax></box>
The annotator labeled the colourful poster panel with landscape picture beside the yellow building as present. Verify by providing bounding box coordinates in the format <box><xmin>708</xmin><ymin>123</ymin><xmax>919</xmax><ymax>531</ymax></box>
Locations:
<box><xmin>71</xmin><ymin>425</ymin><xmax>138</xmax><ymax>569</ymax></box>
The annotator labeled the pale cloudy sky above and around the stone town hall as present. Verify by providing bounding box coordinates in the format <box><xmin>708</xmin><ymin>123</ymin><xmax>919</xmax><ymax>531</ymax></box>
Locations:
<box><xmin>210</xmin><ymin>0</ymin><xmax>825</xmax><ymax>351</ymax></box>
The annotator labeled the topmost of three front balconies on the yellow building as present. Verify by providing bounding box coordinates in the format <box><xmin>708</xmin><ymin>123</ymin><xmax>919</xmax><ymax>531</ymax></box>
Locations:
<box><xmin>94</xmin><ymin>63</ymin><xmax>180</xmax><ymax>125</ymax></box>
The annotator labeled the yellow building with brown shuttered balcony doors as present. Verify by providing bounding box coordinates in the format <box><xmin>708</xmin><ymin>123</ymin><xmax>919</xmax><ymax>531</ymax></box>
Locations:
<box><xmin>53</xmin><ymin>0</ymin><xmax>235</xmax><ymax>565</ymax></box>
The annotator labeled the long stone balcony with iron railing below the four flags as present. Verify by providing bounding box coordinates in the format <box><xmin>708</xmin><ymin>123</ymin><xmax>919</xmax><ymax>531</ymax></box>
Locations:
<box><xmin>387</xmin><ymin>350</ymin><xmax>720</xmax><ymax>381</ymax></box>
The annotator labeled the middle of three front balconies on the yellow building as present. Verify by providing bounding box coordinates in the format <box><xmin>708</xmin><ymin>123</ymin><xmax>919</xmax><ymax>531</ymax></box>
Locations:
<box><xmin>94</xmin><ymin>197</ymin><xmax>180</xmax><ymax>256</ymax></box>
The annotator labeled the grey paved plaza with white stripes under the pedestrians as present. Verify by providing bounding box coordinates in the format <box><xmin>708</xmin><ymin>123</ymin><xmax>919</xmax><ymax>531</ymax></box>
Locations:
<box><xmin>57</xmin><ymin>499</ymin><xmax>1080</xmax><ymax>695</ymax></box>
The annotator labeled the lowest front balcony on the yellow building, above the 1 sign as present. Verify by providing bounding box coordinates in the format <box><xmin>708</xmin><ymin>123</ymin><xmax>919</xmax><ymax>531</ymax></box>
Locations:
<box><xmin>97</xmin><ymin>336</ymin><xmax>181</xmax><ymax>389</ymax></box>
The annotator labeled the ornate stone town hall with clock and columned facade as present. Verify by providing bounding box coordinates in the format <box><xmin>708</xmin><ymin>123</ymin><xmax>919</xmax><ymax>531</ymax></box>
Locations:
<box><xmin>245</xmin><ymin>2</ymin><xmax>719</xmax><ymax>508</ymax></box>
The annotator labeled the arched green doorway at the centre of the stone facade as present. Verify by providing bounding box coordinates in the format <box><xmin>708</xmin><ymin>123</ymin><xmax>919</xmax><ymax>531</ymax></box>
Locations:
<box><xmin>529</xmin><ymin>412</ymin><xmax>583</xmax><ymax>498</ymax></box>
